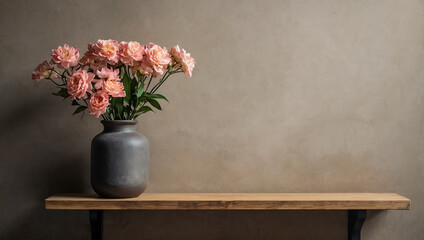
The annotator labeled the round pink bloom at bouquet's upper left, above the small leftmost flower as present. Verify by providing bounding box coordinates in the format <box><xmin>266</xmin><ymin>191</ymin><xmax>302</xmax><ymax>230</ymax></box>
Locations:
<box><xmin>51</xmin><ymin>44</ymin><xmax>79</xmax><ymax>68</ymax></box>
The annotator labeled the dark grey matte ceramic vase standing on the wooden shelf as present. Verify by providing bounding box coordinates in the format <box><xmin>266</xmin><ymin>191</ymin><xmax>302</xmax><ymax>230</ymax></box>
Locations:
<box><xmin>91</xmin><ymin>120</ymin><xmax>149</xmax><ymax>198</ymax></box>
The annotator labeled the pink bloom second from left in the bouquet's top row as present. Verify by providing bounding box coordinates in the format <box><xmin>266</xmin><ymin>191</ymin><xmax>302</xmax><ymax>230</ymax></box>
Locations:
<box><xmin>88</xmin><ymin>39</ymin><xmax>119</xmax><ymax>64</ymax></box>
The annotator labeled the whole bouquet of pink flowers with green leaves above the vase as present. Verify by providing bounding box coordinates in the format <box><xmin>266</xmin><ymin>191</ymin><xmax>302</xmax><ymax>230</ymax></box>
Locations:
<box><xmin>32</xmin><ymin>39</ymin><xmax>195</xmax><ymax>120</ymax></box>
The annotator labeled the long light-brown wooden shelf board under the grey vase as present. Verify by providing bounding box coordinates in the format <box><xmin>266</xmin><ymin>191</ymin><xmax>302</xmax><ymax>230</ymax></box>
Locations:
<box><xmin>45</xmin><ymin>193</ymin><xmax>410</xmax><ymax>210</ymax></box>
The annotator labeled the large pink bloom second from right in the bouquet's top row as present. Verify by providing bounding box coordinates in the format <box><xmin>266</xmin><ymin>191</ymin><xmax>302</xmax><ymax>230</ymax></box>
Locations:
<box><xmin>141</xmin><ymin>43</ymin><xmax>171</xmax><ymax>77</ymax></box>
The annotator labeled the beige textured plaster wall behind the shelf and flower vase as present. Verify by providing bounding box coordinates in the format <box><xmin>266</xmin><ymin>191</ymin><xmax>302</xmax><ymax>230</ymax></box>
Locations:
<box><xmin>0</xmin><ymin>0</ymin><xmax>424</xmax><ymax>240</ymax></box>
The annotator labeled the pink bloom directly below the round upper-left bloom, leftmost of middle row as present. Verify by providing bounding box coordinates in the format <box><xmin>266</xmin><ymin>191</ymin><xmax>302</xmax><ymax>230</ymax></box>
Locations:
<box><xmin>66</xmin><ymin>69</ymin><xmax>94</xmax><ymax>99</ymax></box>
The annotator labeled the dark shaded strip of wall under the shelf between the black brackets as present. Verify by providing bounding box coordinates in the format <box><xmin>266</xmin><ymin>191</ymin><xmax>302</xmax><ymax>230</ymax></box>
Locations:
<box><xmin>104</xmin><ymin>210</ymin><xmax>347</xmax><ymax>240</ymax></box>
